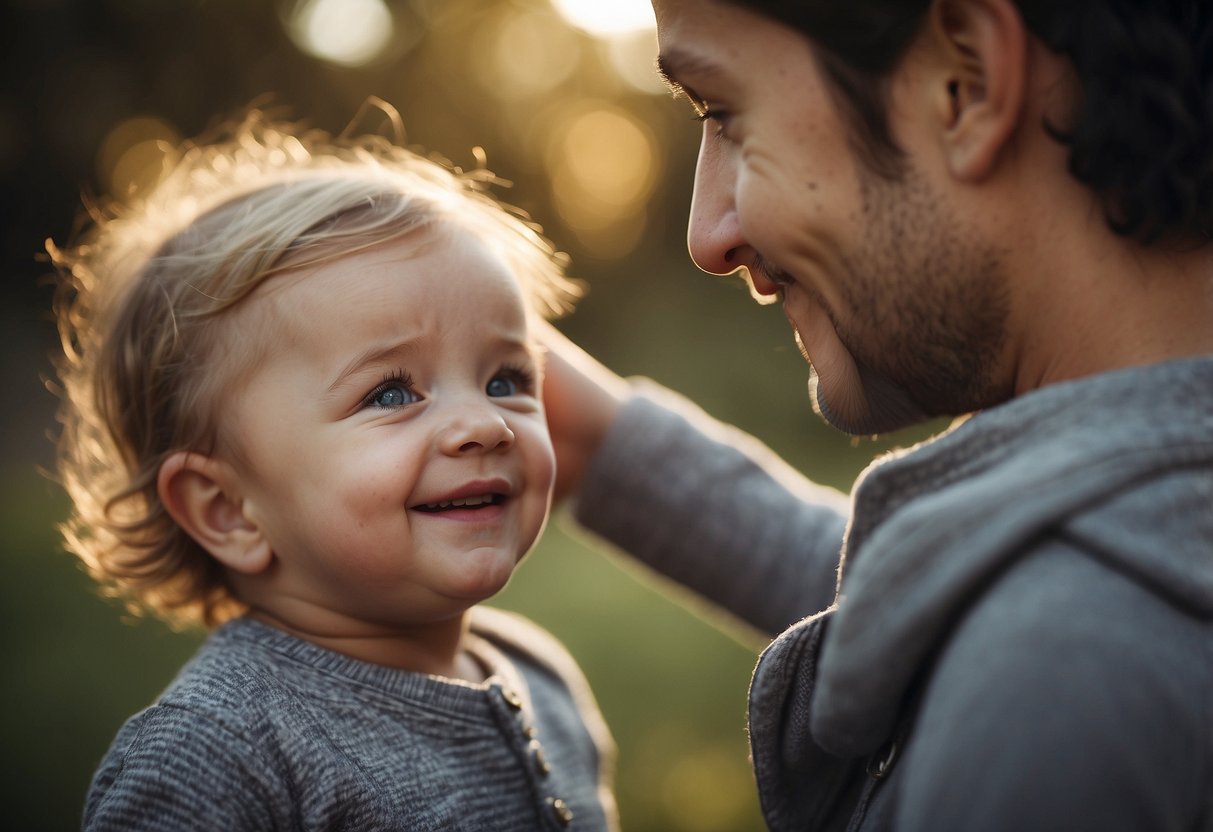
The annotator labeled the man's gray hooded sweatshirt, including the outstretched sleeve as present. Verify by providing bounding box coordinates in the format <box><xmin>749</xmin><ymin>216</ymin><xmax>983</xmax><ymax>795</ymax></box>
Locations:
<box><xmin>576</xmin><ymin>359</ymin><xmax>1213</xmax><ymax>832</ymax></box>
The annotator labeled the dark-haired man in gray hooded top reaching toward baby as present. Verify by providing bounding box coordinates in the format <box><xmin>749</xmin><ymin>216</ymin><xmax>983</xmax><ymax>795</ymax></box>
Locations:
<box><xmin>548</xmin><ymin>0</ymin><xmax>1213</xmax><ymax>832</ymax></box>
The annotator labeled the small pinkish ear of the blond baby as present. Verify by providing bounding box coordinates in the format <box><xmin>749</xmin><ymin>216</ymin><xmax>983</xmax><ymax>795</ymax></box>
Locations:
<box><xmin>156</xmin><ymin>451</ymin><xmax>273</xmax><ymax>575</ymax></box>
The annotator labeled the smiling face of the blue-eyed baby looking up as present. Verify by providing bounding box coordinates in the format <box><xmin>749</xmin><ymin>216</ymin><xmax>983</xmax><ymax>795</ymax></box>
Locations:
<box><xmin>221</xmin><ymin>229</ymin><xmax>556</xmax><ymax>632</ymax></box>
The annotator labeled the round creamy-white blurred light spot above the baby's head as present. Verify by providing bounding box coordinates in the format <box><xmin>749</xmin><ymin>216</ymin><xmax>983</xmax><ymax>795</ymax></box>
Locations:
<box><xmin>286</xmin><ymin>0</ymin><xmax>394</xmax><ymax>67</ymax></box>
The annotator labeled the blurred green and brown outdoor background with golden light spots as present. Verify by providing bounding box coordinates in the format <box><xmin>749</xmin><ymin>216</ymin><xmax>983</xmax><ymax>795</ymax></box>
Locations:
<box><xmin>0</xmin><ymin>0</ymin><xmax>924</xmax><ymax>832</ymax></box>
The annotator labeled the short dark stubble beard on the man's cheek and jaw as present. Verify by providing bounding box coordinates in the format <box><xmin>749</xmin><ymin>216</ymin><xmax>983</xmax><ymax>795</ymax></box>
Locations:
<box><xmin>810</xmin><ymin>163</ymin><xmax>1013</xmax><ymax>435</ymax></box>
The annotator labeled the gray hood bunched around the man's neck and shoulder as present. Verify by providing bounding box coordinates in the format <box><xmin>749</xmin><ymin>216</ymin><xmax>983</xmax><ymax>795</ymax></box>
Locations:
<box><xmin>751</xmin><ymin>358</ymin><xmax>1213</xmax><ymax>781</ymax></box>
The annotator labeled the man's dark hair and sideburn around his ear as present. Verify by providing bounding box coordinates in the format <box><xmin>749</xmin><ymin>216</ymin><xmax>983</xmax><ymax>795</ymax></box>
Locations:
<box><xmin>731</xmin><ymin>0</ymin><xmax>1213</xmax><ymax>244</ymax></box>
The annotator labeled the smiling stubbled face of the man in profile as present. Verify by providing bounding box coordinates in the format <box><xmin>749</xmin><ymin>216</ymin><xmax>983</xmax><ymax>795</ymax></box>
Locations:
<box><xmin>654</xmin><ymin>0</ymin><xmax>1009</xmax><ymax>434</ymax></box>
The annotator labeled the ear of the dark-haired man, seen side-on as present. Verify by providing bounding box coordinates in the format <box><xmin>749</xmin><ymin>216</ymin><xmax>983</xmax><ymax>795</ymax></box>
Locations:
<box><xmin>930</xmin><ymin>0</ymin><xmax>1029</xmax><ymax>182</ymax></box>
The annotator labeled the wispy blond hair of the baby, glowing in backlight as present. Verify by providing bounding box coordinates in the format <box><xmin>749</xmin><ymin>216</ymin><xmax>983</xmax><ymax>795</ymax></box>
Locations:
<box><xmin>47</xmin><ymin>106</ymin><xmax>579</xmax><ymax>626</ymax></box>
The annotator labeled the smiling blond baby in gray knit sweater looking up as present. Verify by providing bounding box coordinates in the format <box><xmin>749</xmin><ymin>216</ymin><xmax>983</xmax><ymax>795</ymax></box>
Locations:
<box><xmin>47</xmin><ymin>112</ymin><xmax>617</xmax><ymax>831</ymax></box>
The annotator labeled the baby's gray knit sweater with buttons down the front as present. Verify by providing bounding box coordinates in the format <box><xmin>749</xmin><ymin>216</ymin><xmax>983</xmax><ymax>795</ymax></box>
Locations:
<box><xmin>84</xmin><ymin>608</ymin><xmax>617</xmax><ymax>832</ymax></box>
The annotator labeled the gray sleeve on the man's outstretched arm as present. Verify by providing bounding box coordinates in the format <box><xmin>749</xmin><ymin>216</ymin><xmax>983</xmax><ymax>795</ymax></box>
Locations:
<box><xmin>574</xmin><ymin>383</ymin><xmax>848</xmax><ymax>636</ymax></box>
